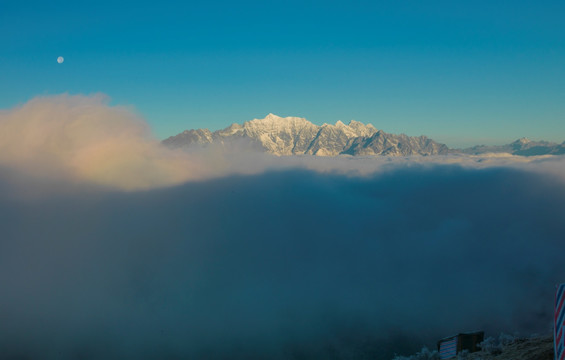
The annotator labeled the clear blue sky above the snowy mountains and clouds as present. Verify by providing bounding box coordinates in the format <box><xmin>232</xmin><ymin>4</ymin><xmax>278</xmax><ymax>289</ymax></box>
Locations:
<box><xmin>0</xmin><ymin>0</ymin><xmax>565</xmax><ymax>146</ymax></box>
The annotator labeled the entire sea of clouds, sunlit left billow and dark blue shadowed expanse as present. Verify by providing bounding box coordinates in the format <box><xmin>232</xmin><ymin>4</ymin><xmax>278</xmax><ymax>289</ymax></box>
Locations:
<box><xmin>0</xmin><ymin>95</ymin><xmax>565</xmax><ymax>359</ymax></box>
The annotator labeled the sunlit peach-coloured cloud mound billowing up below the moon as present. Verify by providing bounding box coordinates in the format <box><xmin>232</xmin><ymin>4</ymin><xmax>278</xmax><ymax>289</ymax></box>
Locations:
<box><xmin>0</xmin><ymin>95</ymin><xmax>203</xmax><ymax>190</ymax></box>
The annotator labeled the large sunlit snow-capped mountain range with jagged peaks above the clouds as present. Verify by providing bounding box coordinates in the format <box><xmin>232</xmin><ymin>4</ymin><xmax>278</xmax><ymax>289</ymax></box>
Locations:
<box><xmin>163</xmin><ymin>114</ymin><xmax>449</xmax><ymax>156</ymax></box>
